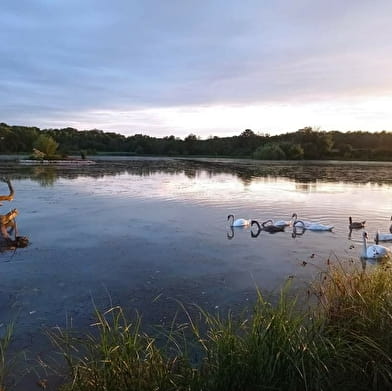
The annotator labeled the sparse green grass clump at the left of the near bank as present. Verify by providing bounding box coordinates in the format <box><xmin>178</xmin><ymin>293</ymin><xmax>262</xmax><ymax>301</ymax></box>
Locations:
<box><xmin>50</xmin><ymin>307</ymin><xmax>198</xmax><ymax>391</ymax></box>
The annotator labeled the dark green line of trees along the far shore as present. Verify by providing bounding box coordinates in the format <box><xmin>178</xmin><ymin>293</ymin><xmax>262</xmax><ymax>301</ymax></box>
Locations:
<box><xmin>0</xmin><ymin>123</ymin><xmax>392</xmax><ymax>160</ymax></box>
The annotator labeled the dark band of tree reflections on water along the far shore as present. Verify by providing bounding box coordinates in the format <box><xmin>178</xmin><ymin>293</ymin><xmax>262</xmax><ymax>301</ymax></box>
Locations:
<box><xmin>0</xmin><ymin>159</ymin><xmax>392</xmax><ymax>191</ymax></box>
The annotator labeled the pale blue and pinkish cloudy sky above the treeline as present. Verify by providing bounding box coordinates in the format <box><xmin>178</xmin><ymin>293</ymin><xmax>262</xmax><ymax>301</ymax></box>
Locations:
<box><xmin>0</xmin><ymin>0</ymin><xmax>392</xmax><ymax>137</ymax></box>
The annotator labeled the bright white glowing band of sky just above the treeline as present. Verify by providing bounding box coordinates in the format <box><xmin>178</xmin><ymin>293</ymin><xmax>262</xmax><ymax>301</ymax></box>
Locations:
<box><xmin>40</xmin><ymin>97</ymin><xmax>392</xmax><ymax>137</ymax></box>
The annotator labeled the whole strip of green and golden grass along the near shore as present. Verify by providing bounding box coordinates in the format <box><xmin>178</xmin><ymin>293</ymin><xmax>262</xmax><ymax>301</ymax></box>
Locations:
<box><xmin>51</xmin><ymin>265</ymin><xmax>392</xmax><ymax>391</ymax></box>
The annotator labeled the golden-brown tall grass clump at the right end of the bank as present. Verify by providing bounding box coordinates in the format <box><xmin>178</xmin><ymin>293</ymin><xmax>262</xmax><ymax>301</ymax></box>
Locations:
<box><xmin>319</xmin><ymin>264</ymin><xmax>392</xmax><ymax>390</ymax></box>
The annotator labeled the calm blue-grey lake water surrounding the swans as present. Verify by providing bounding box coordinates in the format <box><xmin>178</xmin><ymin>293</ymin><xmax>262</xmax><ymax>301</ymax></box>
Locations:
<box><xmin>0</xmin><ymin>159</ymin><xmax>392</xmax><ymax>388</ymax></box>
